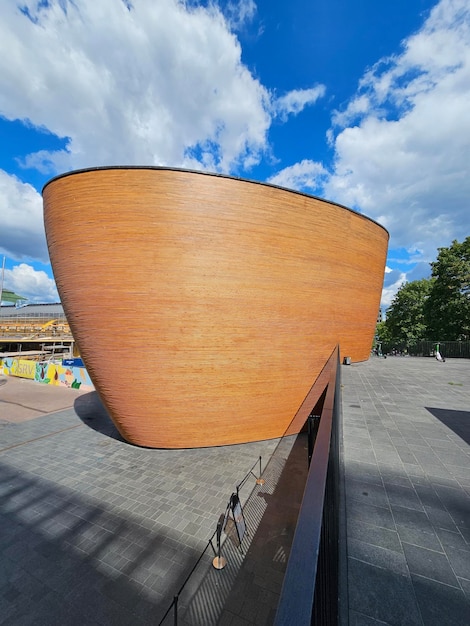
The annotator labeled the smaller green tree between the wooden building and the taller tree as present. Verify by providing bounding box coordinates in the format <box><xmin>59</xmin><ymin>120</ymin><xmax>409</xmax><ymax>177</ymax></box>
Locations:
<box><xmin>385</xmin><ymin>278</ymin><xmax>434</xmax><ymax>350</ymax></box>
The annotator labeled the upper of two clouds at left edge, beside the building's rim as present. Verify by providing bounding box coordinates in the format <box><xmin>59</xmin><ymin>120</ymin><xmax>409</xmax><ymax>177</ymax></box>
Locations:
<box><xmin>0</xmin><ymin>170</ymin><xmax>49</xmax><ymax>263</ymax></box>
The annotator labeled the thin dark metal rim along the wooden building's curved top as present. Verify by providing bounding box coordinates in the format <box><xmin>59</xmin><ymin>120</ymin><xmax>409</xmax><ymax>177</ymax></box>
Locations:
<box><xmin>41</xmin><ymin>165</ymin><xmax>390</xmax><ymax>238</ymax></box>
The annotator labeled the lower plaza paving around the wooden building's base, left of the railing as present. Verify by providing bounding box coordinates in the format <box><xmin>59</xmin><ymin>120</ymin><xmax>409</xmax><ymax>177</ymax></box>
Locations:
<box><xmin>0</xmin><ymin>377</ymin><xmax>307</xmax><ymax>626</ymax></box>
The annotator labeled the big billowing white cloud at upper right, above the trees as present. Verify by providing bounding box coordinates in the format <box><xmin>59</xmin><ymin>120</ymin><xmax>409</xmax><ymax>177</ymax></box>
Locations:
<box><xmin>324</xmin><ymin>0</ymin><xmax>470</xmax><ymax>261</ymax></box>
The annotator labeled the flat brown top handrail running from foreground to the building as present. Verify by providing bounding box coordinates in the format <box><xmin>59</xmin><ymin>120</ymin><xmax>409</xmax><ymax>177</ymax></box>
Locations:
<box><xmin>274</xmin><ymin>347</ymin><xmax>339</xmax><ymax>626</ymax></box>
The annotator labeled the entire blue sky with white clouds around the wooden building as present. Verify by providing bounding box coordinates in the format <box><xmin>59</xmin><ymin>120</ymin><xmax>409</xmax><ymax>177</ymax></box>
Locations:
<box><xmin>0</xmin><ymin>0</ymin><xmax>470</xmax><ymax>307</ymax></box>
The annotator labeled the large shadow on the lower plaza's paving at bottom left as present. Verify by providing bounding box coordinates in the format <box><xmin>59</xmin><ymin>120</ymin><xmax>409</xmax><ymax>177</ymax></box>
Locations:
<box><xmin>0</xmin><ymin>456</ymin><xmax>195</xmax><ymax>626</ymax></box>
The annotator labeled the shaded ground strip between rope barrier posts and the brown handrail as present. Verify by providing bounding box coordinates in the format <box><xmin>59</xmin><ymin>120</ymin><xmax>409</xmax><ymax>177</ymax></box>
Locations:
<box><xmin>177</xmin><ymin>433</ymin><xmax>308</xmax><ymax>626</ymax></box>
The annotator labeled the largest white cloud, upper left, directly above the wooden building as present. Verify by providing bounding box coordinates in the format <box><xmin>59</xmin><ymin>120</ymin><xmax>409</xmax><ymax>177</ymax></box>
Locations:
<box><xmin>0</xmin><ymin>0</ymin><xmax>271</xmax><ymax>173</ymax></box>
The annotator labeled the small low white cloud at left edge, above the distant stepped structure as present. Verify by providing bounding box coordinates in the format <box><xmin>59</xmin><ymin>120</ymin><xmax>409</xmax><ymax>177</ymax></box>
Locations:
<box><xmin>4</xmin><ymin>263</ymin><xmax>59</xmax><ymax>303</ymax></box>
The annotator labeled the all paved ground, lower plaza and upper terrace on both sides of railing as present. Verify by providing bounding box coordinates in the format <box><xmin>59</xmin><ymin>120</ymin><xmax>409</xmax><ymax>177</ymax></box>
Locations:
<box><xmin>0</xmin><ymin>357</ymin><xmax>470</xmax><ymax>626</ymax></box>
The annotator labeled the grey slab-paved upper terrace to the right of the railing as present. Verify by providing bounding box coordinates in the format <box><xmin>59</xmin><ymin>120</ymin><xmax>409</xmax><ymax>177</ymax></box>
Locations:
<box><xmin>342</xmin><ymin>357</ymin><xmax>470</xmax><ymax>626</ymax></box>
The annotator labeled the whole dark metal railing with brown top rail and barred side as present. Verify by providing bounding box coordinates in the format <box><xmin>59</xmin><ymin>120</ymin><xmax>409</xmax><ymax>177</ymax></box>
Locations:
<box><xmin>274</xmin><ymin>348</ymin><xmax>341</xmax><ymax>626</ymax></box>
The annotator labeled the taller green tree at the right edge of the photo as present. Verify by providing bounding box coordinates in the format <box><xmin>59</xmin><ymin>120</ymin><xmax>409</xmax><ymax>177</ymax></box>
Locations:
<box><xmin>425</xmin><ymin>237</ymin><xmax>470</xmax><ymax>341</ymax></box>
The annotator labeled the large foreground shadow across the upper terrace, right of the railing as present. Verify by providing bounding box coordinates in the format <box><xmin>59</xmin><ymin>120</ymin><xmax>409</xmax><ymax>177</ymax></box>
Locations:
<box><xmin>346</xmin><ymin>460</ymin><xmax>470</xmax><ymax>626</ymax></box>
